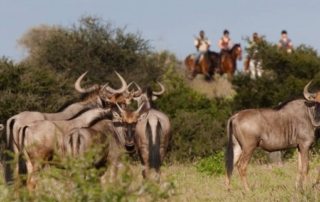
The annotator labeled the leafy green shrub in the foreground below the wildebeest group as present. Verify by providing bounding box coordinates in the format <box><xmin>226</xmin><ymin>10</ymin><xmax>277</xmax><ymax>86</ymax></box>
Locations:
<box><xmin>0</xmin><ymin>148</ymin><xmax>175</xmax><ymax>201</ymax></box>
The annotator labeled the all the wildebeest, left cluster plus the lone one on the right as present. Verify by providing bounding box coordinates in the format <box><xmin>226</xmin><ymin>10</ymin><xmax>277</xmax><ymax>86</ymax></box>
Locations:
<box><xmin>0</xmin><ymin>72</ymin><xmax>320</xmax><ymax>193</ymax></box>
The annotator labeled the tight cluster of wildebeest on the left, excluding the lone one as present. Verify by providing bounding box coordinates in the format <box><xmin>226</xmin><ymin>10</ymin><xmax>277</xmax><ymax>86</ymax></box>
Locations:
<box><xmin>0</xmin><ymin>72</ymin><xmax>170</xmax><ymax>190</ymax></box>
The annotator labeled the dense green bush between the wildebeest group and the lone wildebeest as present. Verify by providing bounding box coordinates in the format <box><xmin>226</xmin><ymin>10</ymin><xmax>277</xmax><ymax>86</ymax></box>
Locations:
<box><xmin>156</xmin><ymin>72</ymin><xmax>230</xmax><ymax>161</ymax></box>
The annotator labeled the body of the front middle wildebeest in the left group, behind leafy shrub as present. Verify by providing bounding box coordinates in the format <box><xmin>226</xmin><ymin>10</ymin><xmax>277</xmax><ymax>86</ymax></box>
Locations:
<box><xmin>63</xmin><ymin>119</ymin><xmax>126</xmax><ymax>182</ymax></box>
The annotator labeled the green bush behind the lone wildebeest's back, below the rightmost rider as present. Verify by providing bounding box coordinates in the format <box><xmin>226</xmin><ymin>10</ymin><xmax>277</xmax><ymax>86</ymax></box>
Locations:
<box><xmin>233</xmin><ymin>38</ymin><xmax>320</xmax><ymax>111</ymax></box>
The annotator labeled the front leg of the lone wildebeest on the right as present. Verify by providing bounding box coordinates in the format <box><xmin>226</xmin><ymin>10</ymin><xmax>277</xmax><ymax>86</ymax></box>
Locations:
<box><xmin>296</xmin><ymin>146</ymin><xmax>309</xmax><ymax>190</ymax></box>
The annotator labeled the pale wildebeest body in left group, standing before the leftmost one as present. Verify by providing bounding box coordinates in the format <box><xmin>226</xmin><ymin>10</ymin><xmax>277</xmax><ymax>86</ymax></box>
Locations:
<box><xmin>12</xmin><ymin>108</ymin><xmax>110</xmax><ymax>189</ymax></box>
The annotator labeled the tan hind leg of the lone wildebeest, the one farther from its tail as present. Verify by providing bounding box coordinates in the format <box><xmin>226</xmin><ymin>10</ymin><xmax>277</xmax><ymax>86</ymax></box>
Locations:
<box><xmin>237</xmin><ymin>147</ymin><xmax>255</xmax><ymax>191</ymax></box>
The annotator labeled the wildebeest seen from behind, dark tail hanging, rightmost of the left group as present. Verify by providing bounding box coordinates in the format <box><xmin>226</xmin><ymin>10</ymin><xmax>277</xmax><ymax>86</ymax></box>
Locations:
<box><xmin>125</xmin><ymin>82</ymin><xmax>171</xmax><ymax>180</ymax></box>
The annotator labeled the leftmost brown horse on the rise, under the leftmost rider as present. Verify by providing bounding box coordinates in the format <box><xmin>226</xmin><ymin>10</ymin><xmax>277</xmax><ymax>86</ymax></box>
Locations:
<box><xmin>184</xmin><ymin>51</ymin><xmax>220</xmax><ymax>81</ymax></box>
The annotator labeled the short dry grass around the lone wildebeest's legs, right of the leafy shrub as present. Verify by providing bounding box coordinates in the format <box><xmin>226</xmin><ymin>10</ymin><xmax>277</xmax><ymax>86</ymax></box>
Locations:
<box><xmin>163</xmin><ymin>156</ymin><xmax>320</xmax><ymax>201</ymax></box>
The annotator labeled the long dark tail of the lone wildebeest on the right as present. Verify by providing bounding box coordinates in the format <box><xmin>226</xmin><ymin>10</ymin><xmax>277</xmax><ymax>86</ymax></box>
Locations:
<box><xmin>225</xmin><ymin>117</ymin><xmax>234</xmax><ymax>178</ymax></box>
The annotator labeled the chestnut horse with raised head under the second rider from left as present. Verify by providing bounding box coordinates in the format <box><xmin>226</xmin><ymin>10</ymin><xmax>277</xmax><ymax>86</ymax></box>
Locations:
<box><xmin>219</xmin><ymin>43</ymin><xmax>242</xmax><ymax>79</ymax></box>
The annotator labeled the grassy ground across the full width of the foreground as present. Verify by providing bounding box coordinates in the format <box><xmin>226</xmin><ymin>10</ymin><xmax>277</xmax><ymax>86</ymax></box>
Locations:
<box><xmin>0</xmin><ymin>154</ymin><xmax>320</xmax><ymax>202</ymax></box>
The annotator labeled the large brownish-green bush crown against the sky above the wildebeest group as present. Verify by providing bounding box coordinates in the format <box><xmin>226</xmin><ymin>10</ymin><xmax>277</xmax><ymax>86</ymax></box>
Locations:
<box><xmin>20</xmin><ymin>16</ymin><xmax>163</xmax><ymax>84</ymax></box>
